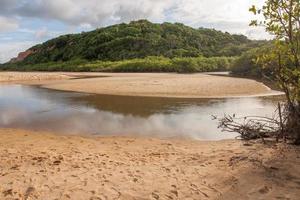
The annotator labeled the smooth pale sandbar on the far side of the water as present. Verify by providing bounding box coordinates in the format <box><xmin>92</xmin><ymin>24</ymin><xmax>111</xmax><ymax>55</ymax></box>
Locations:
<box><xmin>0</xmin><ymin>72</ymin><xmax>278</xmax><ymax>98</ymax></box>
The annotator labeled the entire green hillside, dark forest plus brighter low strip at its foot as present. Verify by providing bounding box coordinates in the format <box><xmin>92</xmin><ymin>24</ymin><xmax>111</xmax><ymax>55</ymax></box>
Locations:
<box><xmin>1</xmin><ymin>20</ymin><xmax>264</xmax><ymax>72</ymax></box>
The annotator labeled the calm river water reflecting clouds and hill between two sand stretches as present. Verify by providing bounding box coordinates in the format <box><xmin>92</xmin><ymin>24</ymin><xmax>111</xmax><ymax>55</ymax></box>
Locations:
<box><xmin>0</xmin><ymin>85</ymin><xmax>277</xmax><ymax>140</ymax></box>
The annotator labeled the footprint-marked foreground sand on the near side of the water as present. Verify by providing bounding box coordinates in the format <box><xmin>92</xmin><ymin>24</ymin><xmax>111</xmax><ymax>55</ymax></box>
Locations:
<box><xmin>0</xmin><ymin>129</ymin><xmax>300</xmax><ymax>200</ymax></box>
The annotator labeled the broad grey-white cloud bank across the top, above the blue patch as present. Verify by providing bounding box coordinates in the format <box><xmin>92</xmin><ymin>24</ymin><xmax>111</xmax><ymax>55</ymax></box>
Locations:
<box><xmin>0</xmin><ymin>0</ymin><xmax>265</xmax><ymax>38</ymax></box>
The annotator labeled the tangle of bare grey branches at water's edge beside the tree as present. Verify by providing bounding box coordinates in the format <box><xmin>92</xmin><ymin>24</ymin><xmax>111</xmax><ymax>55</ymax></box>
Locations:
<box><xmin>213</xmin><ymin>103</ymin><xmax>287</xmax><ymax>142</ymax></box>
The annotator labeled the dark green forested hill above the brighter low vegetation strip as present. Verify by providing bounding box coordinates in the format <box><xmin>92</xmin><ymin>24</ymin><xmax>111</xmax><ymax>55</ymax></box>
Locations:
<box><xmin>7</xmin><ymin>20</ymin><xmax>258</xmax><ymax>65</ymax></box>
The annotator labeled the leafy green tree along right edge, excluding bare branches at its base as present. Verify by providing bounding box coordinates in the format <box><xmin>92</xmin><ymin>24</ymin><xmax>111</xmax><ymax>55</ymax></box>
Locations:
<box><xmin>250</xmin><ymin>0</ymin><xmax>300</xmax><ymax>144</ymax></box>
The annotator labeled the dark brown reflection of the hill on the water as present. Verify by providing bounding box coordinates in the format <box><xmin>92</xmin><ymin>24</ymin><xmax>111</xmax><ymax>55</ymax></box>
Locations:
<box><xmin>73</xmin><ymin>95</ymin><xmax>224</xmax><ymax>117</ymax></box>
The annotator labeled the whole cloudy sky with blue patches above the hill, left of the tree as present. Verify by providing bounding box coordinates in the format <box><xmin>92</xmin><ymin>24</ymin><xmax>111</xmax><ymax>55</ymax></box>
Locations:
<box><xmin>0</xmin><ymin>0</ymin><xmax>269</xmax><ymax>63</ymax></box>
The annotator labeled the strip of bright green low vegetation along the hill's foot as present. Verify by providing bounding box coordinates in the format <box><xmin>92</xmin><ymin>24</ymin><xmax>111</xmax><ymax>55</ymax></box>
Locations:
<box><xmin>1</xmin><ymin>56</ymin><xmax>236</xmax><ymax>73</ymax></box>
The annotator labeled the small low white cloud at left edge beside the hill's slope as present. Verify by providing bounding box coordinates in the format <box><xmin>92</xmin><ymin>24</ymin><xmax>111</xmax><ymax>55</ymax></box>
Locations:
<box><xmin>0</xmin><ymin>41</ymin><xmax>35</xmax><ymax>63</ymax></box>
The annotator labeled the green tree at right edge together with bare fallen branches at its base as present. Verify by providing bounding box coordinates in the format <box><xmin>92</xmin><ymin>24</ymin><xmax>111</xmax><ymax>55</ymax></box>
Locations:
<box><xmin>216</xmin><ymin>0</ymin><xmax>300</xmax><ymax>144</ymax></box>
